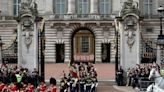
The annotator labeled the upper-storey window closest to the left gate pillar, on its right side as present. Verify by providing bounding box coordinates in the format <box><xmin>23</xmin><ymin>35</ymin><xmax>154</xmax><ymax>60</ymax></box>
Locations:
<box><xmin>53</xmin><ymin>0</ymin><xmax>67</xmax><ymax>14</ymax></box>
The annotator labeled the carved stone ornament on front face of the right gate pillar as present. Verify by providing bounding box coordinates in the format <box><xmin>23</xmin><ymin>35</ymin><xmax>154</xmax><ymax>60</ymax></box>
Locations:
<box><xmin>124</xmin><ymin>16</ymin><xmax>137</xmax><ymax>50</ymax></box>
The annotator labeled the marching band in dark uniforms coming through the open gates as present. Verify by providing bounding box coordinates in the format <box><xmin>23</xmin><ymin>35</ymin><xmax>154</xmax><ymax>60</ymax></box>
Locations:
<box><xmin>60</xmin><ymin>63</ymin><xmax>98</xmax><ymax>92</ymax></box>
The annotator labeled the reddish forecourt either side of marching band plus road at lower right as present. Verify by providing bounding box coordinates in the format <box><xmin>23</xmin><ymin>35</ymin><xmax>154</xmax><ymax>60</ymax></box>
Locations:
<box><xmin>45</xmin><ymin>63</ymin><xmax>138</xmax><ymax>92</ymax></box>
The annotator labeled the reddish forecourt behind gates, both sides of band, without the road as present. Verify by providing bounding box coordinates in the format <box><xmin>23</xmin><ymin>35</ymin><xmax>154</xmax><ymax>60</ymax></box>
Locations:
<box><xmin>45</xmin><ymin>63</ymin><xmax>115</xmax><ymax>80</ymax></box>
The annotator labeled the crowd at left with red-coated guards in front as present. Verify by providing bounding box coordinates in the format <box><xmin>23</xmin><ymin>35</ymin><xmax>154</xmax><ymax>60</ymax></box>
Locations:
<box><xmin>0</xmin><ymin>64</ymin><xmax>57</xmax><ymax>92</ymax></box>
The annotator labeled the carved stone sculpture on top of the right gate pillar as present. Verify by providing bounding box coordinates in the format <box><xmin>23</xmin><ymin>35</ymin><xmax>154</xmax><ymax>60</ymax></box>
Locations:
<box><xmin>120</xmin><ymin>0</ymin><xmax>139</xmax><ymax>16</ymax></box>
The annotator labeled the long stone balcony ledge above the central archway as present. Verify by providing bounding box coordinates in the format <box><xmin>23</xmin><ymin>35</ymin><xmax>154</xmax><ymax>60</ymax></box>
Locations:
<box><xmin>43</xmin><ymin>14</ymin><xmax>116</xmax><ymax>20</ymax></box>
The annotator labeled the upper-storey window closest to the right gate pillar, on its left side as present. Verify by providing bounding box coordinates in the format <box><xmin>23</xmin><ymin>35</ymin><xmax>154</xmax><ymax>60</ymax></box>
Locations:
<box><xmin>99</xmin><ymin>0</ymin><xmax>112</xmax><ymax>14</ymax></box>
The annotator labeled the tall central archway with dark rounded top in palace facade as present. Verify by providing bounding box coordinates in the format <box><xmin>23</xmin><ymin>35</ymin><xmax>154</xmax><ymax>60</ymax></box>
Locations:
<box><xmin>71</xmin><ymin>28</ymin><xmax>95</xmax><ymax>62</ymax></box>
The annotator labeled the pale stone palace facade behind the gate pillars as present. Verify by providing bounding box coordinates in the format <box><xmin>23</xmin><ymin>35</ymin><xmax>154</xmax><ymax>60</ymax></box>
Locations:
<box><xmin>0</xmin><ymin>0</ymin><xmax>164</xmax><ymax>68</ymax></box>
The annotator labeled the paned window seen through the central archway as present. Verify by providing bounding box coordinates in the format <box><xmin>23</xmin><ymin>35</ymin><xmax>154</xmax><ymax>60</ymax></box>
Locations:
<box><xmin>81</xmin><ymin>36</ymin><xmax>89</xmax><ymax>53</ymax></box>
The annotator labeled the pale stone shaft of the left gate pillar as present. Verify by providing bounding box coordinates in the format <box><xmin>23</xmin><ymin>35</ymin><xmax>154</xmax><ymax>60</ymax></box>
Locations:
<box><xmin>18</xmin><ymin>23</ymin><xmax>38</xmax><ymax>71</ymax></box>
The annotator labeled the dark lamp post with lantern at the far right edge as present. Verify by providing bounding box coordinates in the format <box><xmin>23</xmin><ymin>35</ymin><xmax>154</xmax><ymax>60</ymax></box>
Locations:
<box><xmin>157</xmin><ymin>6</ymin><xmax>164</xmax><ymax>63</ymax></box>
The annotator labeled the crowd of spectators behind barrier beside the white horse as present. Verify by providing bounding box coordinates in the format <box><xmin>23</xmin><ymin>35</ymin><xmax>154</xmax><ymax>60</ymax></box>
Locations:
<box><xmin>127</xmin><ymin>63</ymin><xmax>160</xmax><ymax>88</ymax></box>
